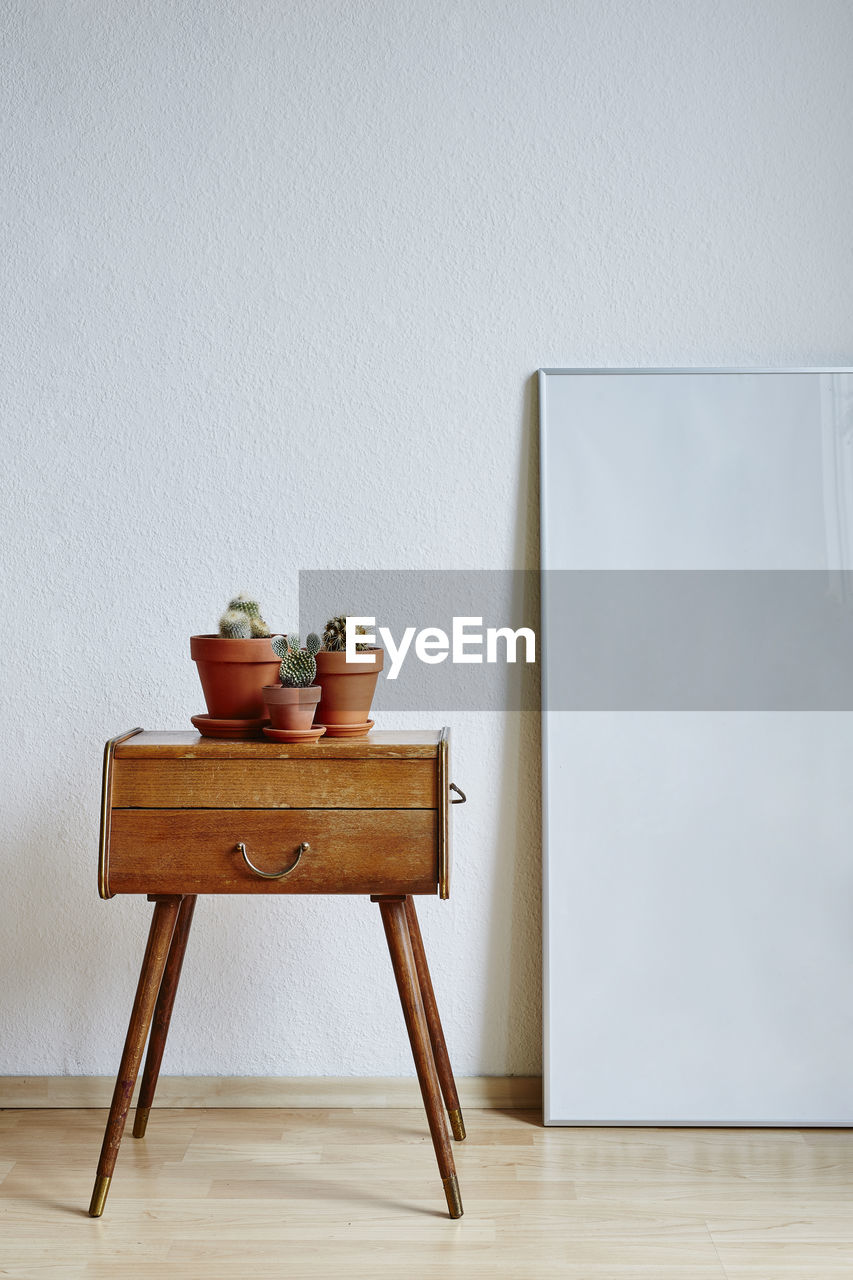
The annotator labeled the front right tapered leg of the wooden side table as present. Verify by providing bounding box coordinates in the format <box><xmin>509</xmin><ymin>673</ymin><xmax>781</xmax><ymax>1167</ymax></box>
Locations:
<box><xmin>374</xmin><ymin>897</ymin><xmax>462</xmax><ymax>1217</ymax></box>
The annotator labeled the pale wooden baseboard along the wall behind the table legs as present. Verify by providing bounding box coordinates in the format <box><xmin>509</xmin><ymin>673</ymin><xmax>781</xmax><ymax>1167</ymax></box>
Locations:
<box><xmin>0</xmin><ymin>1075</ymin><xmax>542</xmax><ymax>1111</ymax></box>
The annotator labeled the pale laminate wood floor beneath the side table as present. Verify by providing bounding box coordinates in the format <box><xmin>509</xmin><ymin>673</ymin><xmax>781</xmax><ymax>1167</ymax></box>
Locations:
<box><xmin>0</xmin><ymin>1108</ymin><xmax>853</xmax><ymax>1280</ymax></box>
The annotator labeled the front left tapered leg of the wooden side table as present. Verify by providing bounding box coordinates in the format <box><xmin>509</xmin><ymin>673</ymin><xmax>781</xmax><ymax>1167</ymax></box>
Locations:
<box><xmin>88</xmin><ymin>896</ymin><xmax>181</xmax><ymax>1217</ymax></box>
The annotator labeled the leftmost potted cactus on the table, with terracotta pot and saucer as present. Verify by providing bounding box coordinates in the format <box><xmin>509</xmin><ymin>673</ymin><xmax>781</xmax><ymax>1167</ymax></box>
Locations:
<box><xmin>190</xmin><ymin>594</ymin><xmax>279</xmax><ymax>732</ymax></box>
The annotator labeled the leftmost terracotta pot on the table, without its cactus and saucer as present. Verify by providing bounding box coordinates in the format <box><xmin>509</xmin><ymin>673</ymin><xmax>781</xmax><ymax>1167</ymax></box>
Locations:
<box><xmin>190</xmin><ymin>635</ymin><xmax>280</xmax><ymax>719</ymax></box>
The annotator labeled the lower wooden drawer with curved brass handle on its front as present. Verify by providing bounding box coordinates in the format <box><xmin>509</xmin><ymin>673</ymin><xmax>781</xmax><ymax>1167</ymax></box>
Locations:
<box><xmin>105</xmin><ymin>814</ymin><xmax>438</xmax><ymax>897</ymax></box>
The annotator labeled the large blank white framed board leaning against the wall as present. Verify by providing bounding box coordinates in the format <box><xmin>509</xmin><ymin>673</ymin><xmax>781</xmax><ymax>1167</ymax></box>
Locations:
<box><xmin>539</xmin><ymin>369</ymin><xmax>853</xmax><ymax>1125</ymax></box>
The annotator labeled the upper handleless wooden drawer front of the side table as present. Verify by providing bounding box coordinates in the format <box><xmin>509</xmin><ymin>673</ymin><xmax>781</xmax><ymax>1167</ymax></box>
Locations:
<box><xmin>111</xmin><ymin>758</ymin><xmax>437</xmax><ymax>809</ymax></box>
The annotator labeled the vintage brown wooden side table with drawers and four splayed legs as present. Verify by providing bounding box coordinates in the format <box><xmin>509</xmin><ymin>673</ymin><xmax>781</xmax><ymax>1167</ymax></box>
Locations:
<box><xmin>88</xmin><ymin>728</ymin><xmax>465</xmax><ymax>1217</ymax></box>
